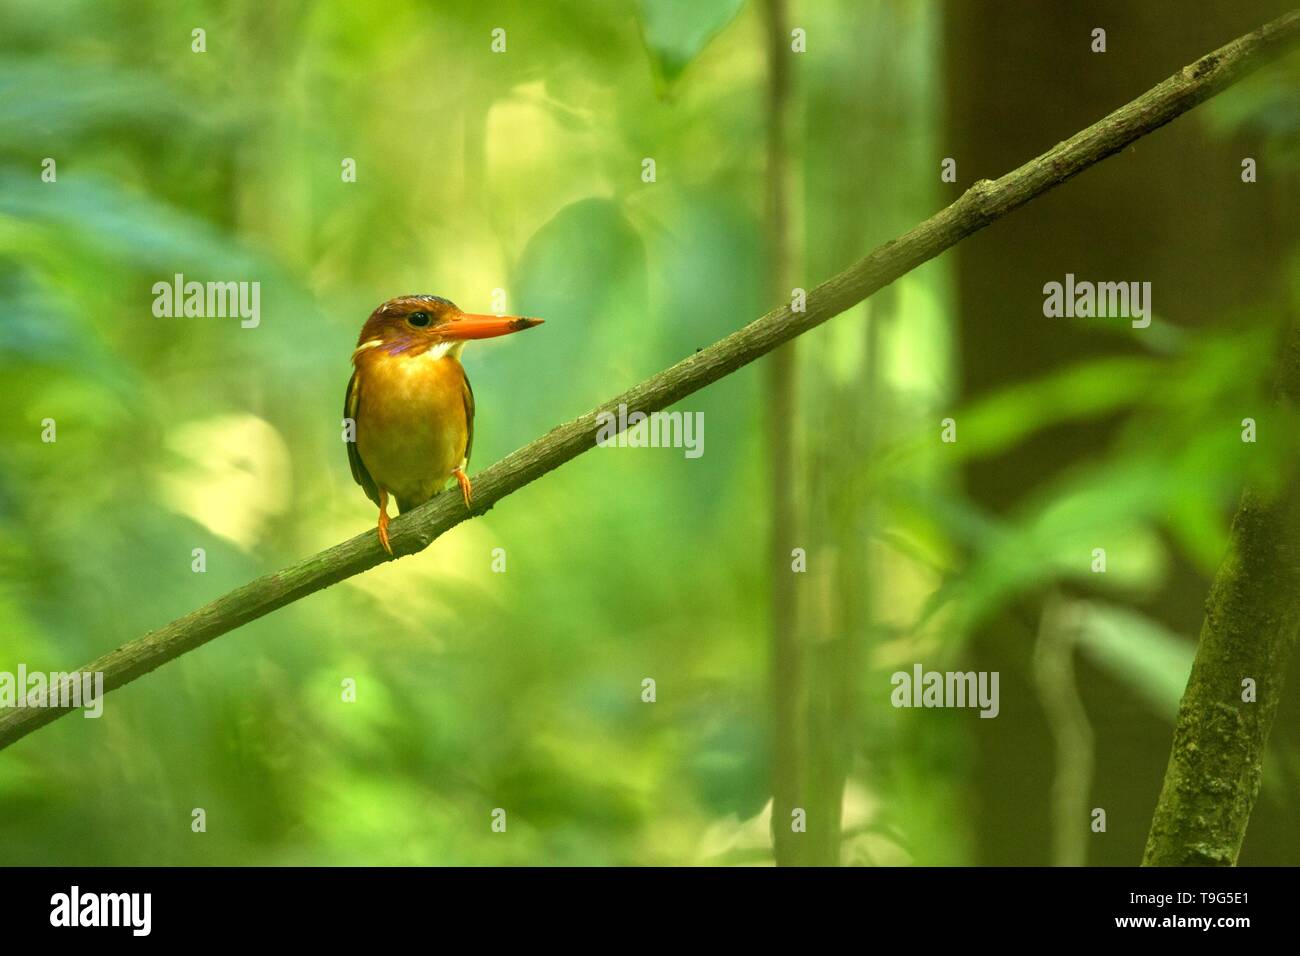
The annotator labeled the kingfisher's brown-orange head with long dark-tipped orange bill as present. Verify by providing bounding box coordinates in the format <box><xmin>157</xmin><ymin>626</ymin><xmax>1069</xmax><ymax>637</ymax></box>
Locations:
<box><xmin>356</xmin><ymin>295</ymin><xmax>542</xmax><ymax>356</ymax></box>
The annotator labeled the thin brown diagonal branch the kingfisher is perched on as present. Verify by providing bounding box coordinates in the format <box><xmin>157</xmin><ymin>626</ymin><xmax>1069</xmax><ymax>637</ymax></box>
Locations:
<box><xmin>0</xmin><ymin>10</ymin><xmax>1300</xmax><ymax>749</ymax></box>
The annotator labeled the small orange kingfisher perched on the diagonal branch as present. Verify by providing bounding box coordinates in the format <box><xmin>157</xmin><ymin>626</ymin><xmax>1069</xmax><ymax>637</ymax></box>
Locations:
<box><xmin>343</xmin><ymin>295</ymin><xmax>542</xmax><ymax>554</ymax></box>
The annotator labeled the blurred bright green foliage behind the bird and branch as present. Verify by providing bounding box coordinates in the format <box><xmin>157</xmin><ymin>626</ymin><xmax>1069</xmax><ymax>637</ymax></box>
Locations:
<box><xmin>0</xmin><ymin>0</ymin><xmax>1300</xmax><ymax>865</ymax></box>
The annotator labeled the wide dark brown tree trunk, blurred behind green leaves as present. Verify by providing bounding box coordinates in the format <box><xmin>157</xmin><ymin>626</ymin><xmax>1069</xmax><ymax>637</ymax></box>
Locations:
<box><xmin>944</xmin><ymin>0</ymin><xmax>1295</xmax><ymax>865</ymax></box>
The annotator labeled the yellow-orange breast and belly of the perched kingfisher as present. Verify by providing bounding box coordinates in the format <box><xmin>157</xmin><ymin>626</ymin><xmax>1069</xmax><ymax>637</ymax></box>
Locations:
<box><xmin>356</xmin><ymin>349</ymin><xmax>469</xmax><ymax>507</ymax></box>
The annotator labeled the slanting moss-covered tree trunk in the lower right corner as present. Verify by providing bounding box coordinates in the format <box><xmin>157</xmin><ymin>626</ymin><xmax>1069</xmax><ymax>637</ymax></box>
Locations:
<box><xmin>1143</xmin><ymin>326</ymin><xmax>1300</xmax><ymax>866</ymax></box>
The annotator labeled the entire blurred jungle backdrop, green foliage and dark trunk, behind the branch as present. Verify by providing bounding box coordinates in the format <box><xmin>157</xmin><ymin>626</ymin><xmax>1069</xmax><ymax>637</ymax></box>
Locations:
<box><xmin>0</xmin><ymin>0</ymin><xmax>1300</xmax><ymax>865</ymax></box>
